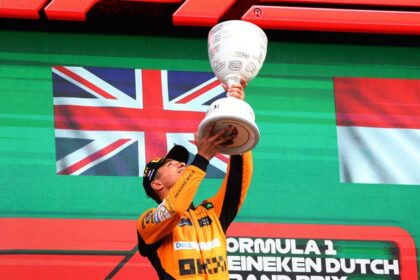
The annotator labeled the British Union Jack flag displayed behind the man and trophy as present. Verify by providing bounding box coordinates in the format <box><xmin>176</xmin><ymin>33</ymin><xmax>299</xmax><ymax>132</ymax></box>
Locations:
<box><xmin>52</xmin><ymin>66</ymin><xmax>228</xmax><ymax>178</ymax></box>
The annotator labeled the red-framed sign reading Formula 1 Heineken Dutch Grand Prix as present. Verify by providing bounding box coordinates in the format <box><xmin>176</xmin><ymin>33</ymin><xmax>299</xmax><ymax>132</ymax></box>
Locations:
<box><xmin>228</xmin><ymin>223</ymin><xmax>417</xmax><ymax>280</ymax></box>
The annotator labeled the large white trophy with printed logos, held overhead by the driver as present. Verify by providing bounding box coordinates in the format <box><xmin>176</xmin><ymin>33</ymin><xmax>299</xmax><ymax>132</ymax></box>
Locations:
<box><xmin>198</xmin><ymin>20</ymin><xmax>267</xmax><ymax>155</ymax></box>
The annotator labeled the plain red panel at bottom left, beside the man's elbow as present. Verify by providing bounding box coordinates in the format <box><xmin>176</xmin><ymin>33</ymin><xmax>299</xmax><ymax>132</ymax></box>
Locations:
<box><xmin>0</xmin><ymin>218</ymin><xmax>157</xmax><ymax>280</ymax></box>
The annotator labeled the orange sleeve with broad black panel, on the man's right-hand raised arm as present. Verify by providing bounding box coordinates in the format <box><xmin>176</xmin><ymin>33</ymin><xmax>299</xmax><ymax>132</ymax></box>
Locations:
<box><xmin>208</xmin><ymin>151</ymin><xmax>253</xmax><ymax>232</ymax></box>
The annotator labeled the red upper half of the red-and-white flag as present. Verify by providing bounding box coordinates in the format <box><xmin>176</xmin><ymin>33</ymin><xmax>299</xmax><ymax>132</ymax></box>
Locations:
<box><xmin>334</xmin><ymin>78</ymin><xmax>420</xmax><ymax>129</ymax></box>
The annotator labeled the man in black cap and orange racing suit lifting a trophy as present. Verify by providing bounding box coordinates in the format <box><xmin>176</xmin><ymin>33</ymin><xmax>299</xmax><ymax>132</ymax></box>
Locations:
<box><xmin>137</xmin><ymin>84</ymin><xmax>253</xmax><ymax>279</ymax></box>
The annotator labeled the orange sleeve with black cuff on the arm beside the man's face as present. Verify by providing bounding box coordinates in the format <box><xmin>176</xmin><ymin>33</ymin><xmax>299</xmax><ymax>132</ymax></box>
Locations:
<box><xmin>137</xmin><ymin>155</ymin><xmax>208</xmax><ymax>244</ymax></box>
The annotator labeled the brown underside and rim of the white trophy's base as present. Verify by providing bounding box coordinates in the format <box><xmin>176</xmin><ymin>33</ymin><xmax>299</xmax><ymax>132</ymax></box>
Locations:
<box><xmin>198</xmin><ymin>112</ymin><xmax>260</xmax><ymax>155</ymax></box>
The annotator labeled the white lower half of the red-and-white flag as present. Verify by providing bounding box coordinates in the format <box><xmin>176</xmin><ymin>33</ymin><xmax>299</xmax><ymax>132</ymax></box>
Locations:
<box><xmin>337</xmin><ymin>126</ymin><xmax>420</xmax><ymax>185</ymax></box>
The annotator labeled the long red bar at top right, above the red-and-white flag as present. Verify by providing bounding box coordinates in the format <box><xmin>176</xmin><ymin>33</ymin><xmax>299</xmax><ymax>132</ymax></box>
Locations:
<box><xmin>241</xmin><ymin>5</ymin><xmax>420</xmax><ymax>34</ymax></box>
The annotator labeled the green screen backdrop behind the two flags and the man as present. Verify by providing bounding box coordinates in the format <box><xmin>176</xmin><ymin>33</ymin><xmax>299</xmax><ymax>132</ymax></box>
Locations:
<box><xmin>0</xmin><ymin>21</ymin><xmax>420</xmax><ymax>278</ymax></box>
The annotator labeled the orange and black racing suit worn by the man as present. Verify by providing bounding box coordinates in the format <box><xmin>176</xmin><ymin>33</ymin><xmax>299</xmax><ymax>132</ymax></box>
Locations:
<box><xmin>137</xmin><ymin>152</ymin><xmax>253</xmax><ymax>279</ymax></box>
